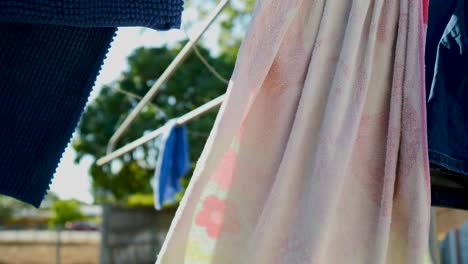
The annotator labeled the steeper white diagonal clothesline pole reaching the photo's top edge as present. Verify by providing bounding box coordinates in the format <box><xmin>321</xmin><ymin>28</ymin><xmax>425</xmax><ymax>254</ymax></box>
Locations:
<box><xmin>106</xmin><ymin>0</ymin><xmax>229</xmax><ymax>154</ymax></box>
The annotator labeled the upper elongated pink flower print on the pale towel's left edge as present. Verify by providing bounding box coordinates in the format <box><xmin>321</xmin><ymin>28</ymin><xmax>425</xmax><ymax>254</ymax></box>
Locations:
<box><xmin>211</xmin><ymin>148</ymin><xmax>237</xmax><ymax>190</ymax></box>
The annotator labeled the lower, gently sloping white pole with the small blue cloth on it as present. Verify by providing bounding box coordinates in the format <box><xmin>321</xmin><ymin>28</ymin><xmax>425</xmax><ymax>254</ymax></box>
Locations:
<box><xmin>96</xmin><ymin>95</ymin><xmax>225</xmax><ymax>166</ymax></box>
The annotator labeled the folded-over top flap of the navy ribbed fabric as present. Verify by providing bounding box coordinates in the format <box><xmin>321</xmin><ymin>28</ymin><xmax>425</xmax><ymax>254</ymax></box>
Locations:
<box><xmin>0</xmin><ymin>0</ymin><xmax>183</xmax><ymax>29</ymax></box>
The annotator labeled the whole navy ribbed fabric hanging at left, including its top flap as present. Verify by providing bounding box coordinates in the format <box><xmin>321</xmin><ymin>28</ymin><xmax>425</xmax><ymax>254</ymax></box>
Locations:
<box><xmin>0</xmin><ymin>0</ymin><xmax>183</xmax><ymax>207</ymax></box>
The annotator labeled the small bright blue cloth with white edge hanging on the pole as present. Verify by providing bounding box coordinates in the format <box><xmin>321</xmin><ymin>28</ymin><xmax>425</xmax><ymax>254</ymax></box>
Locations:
<box><xmin>153</xmin><ymin>119</ymin><xmax>190</xmax><ymax>210</ymax></box>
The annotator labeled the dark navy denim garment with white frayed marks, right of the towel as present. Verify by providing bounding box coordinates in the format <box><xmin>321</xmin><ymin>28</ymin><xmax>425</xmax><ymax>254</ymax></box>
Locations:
<box><xmin>425</xmin><ymin>0</ymin><xmax>468</xmax><ymax>209</ymax></box>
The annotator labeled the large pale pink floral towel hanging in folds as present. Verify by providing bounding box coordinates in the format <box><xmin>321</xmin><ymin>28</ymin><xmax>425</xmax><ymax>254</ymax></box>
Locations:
<box><xmin>157</xmin><ymin>0</ymin><xmax>430</xmax><ymax>264</ymax></box>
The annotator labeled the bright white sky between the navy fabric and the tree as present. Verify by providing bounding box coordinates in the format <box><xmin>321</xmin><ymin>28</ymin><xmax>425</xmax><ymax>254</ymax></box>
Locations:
<box><xmin>50</xmin><ymin>10</ymin><xmax>219</xmax><ymax>203</ymax></box>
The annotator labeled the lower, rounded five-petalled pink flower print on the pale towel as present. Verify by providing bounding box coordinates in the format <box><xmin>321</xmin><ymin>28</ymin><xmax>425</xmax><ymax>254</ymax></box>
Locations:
<box><xmin>195</xmin><ymin>195</ymin><xmax>240</xmax><ymax>239</ymax></box>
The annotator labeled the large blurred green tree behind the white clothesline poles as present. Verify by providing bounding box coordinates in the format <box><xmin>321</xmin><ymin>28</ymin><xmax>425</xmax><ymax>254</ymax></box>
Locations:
<box><xmin>73</xmin><ymin>43</ymin><xmax>234</xmax><ymax>203</ymax></box>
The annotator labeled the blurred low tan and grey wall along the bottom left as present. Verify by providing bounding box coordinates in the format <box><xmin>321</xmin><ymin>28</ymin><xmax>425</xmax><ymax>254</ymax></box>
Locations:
<box><xmin>0</xmin><ymin>205</ymin><xmax>175</xmax><ymax>264</ymax></box>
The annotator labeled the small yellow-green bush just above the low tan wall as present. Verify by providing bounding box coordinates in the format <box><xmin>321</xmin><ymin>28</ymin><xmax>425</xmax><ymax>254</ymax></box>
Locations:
<box><xmin>49</xmin><ymin>200</ymin><xmax>85</xmax><ymax>226</ymax></box>
